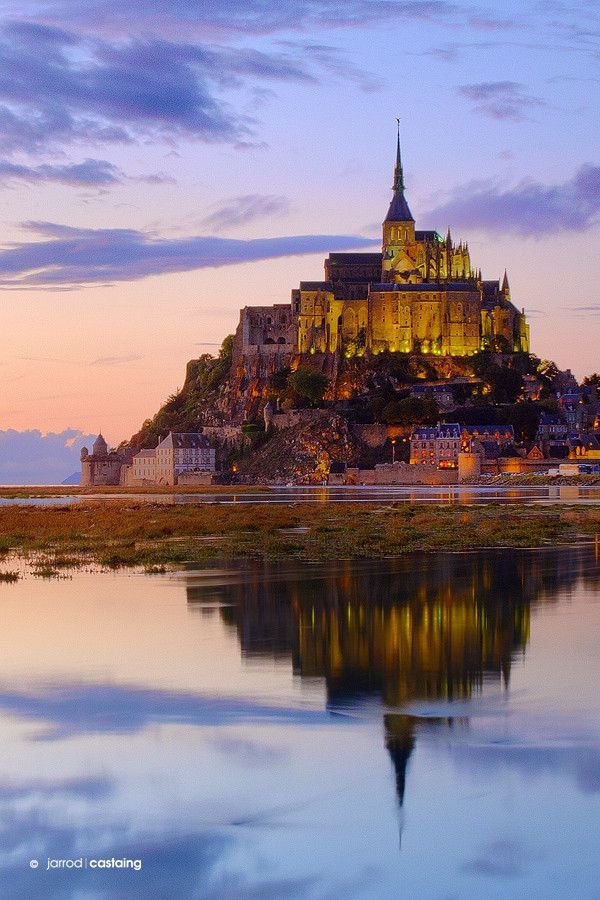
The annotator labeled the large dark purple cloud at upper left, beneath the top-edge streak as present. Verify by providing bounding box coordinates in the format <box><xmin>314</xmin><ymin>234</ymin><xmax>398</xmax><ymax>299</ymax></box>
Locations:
<box><xmin>0</xmin><ymin>22</ymin><xmax>316</xmax><ymax>151</ymax></box>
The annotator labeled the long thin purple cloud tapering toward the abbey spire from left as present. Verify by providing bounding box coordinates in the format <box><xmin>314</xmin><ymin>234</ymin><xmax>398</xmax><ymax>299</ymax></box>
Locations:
<box><xmin>0</xmin><ymin>222</ymin><xmax>379</xmax><ymax>288</ymax></box>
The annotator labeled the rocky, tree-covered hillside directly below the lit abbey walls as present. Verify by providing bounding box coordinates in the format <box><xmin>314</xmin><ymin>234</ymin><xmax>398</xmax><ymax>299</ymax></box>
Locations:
<box><xmin>126</xmin><ymin>335</ymin><xmax>558</xmax><ymax>460</ymax></box>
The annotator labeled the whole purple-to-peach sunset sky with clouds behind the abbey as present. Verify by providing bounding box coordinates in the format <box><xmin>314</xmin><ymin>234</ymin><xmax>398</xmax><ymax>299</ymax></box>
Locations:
<box><xmin>0</xmin><ymin>0</ymin><xmax>600</xmax><ymax>464</ymax></box>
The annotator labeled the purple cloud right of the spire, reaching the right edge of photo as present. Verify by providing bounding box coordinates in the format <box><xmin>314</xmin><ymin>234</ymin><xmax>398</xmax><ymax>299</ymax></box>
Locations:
<box><xmin>426</xmin><ymin>164</ymin><xmax>600</xmax><ymax>237</ymax></box>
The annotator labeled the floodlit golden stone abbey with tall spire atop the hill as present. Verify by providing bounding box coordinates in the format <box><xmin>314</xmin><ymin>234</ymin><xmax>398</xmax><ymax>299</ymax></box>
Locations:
<box><xmin>236</xmin><ymin>135</ymin><xmax>529</xmax><ymax>362</ymax></box>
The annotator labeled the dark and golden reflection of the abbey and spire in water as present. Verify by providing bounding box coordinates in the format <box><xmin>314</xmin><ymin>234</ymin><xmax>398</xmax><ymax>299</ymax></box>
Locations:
<box><xmin>188</xmin><ymin>548</ymin><xmax>600</xmax><ymax>816</ymax></box>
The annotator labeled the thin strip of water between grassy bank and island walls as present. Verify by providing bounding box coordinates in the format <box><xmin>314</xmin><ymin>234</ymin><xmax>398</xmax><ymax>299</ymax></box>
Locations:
<box><xmin>0</xmin><ymin>479</ymin><xmax>600</xmax><ymax>506</ymax></box>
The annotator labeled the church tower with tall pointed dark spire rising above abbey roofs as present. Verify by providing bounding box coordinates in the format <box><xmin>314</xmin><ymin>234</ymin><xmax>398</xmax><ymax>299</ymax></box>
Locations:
<box><xmin>381</xmin><ymin>119</ymin><xmax>418</xmax><ymax>282</ymax></box>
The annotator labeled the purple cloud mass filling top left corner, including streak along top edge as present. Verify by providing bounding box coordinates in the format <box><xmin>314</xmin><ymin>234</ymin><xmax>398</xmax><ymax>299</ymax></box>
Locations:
<box><xmin>0</xmin><ymin>0</ymin><xmax>460</xmax><ymax>157</ymax></box>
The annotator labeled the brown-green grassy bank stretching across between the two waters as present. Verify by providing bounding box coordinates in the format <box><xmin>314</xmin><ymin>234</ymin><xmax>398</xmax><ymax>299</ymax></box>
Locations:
<box><xmin>0</xmin><ymin>498</ymin><xmax>600</xmax><ymax>574</ymax></box>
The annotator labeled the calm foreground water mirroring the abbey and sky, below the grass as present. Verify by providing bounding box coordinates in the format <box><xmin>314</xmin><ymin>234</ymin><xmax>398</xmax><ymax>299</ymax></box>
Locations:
<box><xmin>0</xmin><ymin>546</ymin><xmax>600</xmax><ymax>900</ymax></box>
